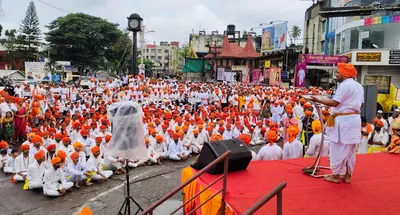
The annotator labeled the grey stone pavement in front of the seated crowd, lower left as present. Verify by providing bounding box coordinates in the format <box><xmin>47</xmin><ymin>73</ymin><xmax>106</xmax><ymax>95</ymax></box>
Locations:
<box><xmin>0</xmin><ymin>146</ymin><xmax>266</xmax><ymax>215</ymax></box>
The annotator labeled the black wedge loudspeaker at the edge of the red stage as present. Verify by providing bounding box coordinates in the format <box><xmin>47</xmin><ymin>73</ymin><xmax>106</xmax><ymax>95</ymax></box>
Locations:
<box><xmin>197</xmin><ymin>139</ymin><xmax>252</xmax><ymax>174</ymax></box>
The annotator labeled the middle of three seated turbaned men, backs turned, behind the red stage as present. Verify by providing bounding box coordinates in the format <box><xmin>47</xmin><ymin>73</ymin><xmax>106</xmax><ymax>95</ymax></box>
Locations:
<box><xmin>283</xmin><ymin>125</ymin><xmax>303</xmax><ymax>160</ymax></box>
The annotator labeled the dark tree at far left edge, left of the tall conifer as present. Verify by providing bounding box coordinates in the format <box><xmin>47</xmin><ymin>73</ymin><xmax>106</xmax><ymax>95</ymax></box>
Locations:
<box><xmin>0</xmin><ymin>29</ymin><xmax>19</xmax><ymax>69</ymax></box>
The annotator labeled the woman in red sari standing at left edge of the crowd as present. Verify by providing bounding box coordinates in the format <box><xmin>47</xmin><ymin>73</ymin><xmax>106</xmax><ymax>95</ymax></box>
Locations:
<box><xmin>14</xmin><ymin>98</ymin><xmax>27</xmax><ymax>141</ymax></box>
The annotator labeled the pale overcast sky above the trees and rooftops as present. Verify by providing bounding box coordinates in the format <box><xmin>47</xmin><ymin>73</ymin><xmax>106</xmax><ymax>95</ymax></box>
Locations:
<box><xmin>0</xmin><ymin>0</ymin><xmax>312</xmax><ymax>43</ymax></box>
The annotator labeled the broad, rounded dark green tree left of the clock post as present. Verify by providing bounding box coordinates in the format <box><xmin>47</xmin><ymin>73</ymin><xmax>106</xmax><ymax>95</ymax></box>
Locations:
<box><xmin>45</xmin><ymin>13</ymin><xmax>123</xmax><ymax>70</ymax></box>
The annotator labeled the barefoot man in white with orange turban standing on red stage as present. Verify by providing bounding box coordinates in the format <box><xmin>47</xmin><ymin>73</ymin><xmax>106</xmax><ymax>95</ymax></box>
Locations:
<box><xmin>311</xmin><ymin>63</ymin><xmax>364</xmax><ymax>183</ymax></box>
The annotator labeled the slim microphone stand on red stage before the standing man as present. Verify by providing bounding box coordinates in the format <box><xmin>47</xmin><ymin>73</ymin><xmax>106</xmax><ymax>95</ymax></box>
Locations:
<box><xmin>303</xmin><ymin>101</ymin><xmax>331</xmax><ymax>178</ymax></box>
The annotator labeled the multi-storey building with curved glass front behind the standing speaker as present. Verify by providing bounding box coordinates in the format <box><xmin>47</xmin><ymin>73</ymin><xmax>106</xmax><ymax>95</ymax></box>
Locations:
<box><xmin>321</xmin><ymin>0</ymin><xmax>400</xmax><ymax>86</ymax></box>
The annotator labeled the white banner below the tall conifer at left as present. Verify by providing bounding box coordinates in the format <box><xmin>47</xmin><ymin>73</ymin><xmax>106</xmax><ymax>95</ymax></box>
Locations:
<box><xmin>25</xmin><ymin>62</ymin><xmax>51</xmax><ymax>81</ymax></box>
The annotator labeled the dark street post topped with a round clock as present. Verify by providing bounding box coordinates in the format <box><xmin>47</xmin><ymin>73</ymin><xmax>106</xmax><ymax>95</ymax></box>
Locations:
<box><xmin>127</xmin><ymin>13</ymin><xmax>143</xmax><ymax>75</ymax></box>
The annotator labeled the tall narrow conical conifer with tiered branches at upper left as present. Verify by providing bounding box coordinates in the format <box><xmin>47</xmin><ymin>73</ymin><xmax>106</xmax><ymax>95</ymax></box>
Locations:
<box><xmin>17</xmin><ymin>1</ymin><xmax>42</xmax><ymax>61</ymax></box>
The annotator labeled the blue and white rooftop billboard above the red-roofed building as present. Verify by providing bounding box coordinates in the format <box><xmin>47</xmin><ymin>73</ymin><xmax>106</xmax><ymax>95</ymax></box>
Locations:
<box><xmin>261</xmin><ymin>22</ymin><xmax>287</xmax><ymax>52</ymax></box>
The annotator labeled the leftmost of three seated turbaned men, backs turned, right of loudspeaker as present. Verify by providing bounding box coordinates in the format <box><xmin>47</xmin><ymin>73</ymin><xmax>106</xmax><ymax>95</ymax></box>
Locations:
<box><xmin>257</xmin><ymin>130</ymin><xmax>283</xmax><ymax>160</ymax></box>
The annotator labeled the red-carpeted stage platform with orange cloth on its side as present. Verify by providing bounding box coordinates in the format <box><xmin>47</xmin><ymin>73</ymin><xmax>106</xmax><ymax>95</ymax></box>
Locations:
<box><xmin>182</xmin><ymin>153</ymin><xmax>400</xmax><ymax>215</ymax></box>
